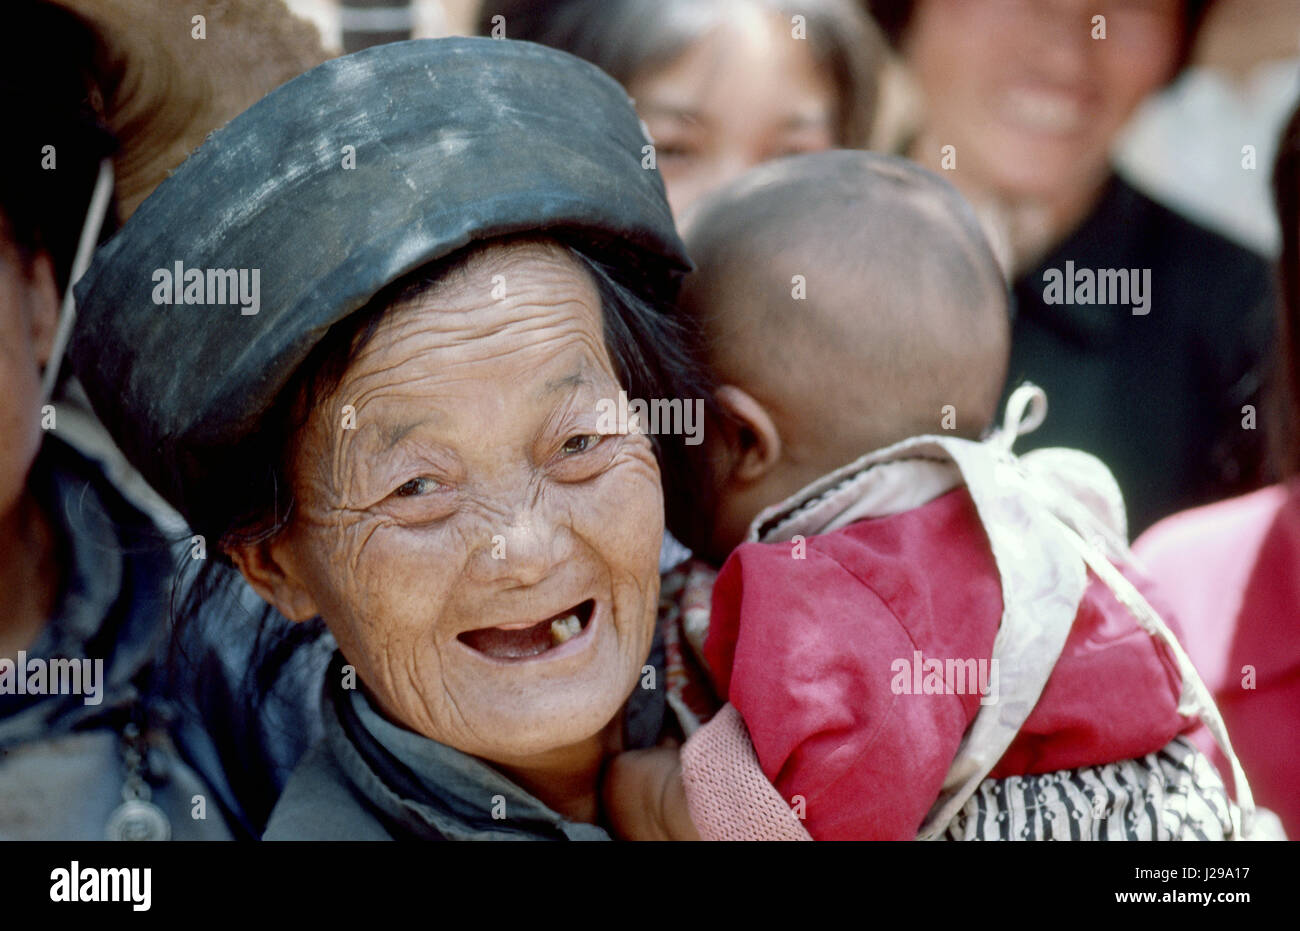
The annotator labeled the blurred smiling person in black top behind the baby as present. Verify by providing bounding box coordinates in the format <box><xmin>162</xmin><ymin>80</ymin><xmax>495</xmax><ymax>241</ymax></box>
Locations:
<box><xmin>870</xmin><ymin>0</ymin><xmax>1271</xmax><ymax>533</ymax></box>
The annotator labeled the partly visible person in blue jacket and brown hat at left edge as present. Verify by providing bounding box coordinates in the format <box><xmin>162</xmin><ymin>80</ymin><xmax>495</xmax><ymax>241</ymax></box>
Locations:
<box><xmin>0</xmin><ymin>0</ymin><xmax>324</xmax><ymax>840</ymax></box>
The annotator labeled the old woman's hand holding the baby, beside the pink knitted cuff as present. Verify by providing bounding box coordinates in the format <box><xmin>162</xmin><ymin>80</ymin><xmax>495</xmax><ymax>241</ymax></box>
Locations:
<box><xmin>601</xmin><ymin>744</ymin><xmax>699</xmax><ymax>840</ymax></box>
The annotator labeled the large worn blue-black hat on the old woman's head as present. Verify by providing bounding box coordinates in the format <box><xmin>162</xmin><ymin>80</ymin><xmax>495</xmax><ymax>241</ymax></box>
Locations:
<box><xmin>72</xmin><ymin>38</ymin><xmax>689</xmax><ymax>514</ymax></box>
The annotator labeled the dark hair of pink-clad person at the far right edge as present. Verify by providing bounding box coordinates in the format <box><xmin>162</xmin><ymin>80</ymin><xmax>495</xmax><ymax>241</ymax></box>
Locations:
<box><xmin>1273</xmin><ymin>100</ymin><xmax>1300</xmax><ymax>476</ymax></box>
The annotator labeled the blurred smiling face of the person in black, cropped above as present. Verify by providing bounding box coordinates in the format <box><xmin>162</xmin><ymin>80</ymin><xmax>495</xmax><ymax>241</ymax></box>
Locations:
<box><xmin>905</xmin><ymin>0</ymin><xmax>1183</xmax><ymax>199</ymax></box>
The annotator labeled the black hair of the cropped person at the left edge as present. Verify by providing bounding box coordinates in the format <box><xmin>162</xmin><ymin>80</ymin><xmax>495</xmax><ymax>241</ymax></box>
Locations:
<box><xmin>0</xmin><ymin>0</ymin><xmax>116</xmax><ymax>294</ymax></box>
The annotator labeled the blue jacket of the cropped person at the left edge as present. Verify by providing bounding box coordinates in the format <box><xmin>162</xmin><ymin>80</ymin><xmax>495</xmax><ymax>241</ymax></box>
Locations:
<box><xmin>0</xmin><ymin>433</ymin><xmax>230</xmax><ymax>840</ymax></box>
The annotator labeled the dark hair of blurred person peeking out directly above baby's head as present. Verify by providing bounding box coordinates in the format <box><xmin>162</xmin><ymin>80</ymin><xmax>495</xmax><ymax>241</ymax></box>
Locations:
<box><xmin>477</xmin><ymin>0</ymin><xmax>885</xmax><ymax>148</ymax></box>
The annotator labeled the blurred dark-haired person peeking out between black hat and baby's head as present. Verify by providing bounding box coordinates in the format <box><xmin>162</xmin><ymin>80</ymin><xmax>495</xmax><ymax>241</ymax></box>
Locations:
<box><xmin>478</xmin><ymin>0</ymin><xmax>887</xmax><ymax>217</ymax></box>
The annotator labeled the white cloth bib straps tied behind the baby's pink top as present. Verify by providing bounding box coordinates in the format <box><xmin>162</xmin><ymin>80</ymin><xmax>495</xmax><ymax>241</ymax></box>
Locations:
<box><xmin>749</xmin><ymin>385</ymin><xmax>1253</xmax><ymax>840</ymax></box>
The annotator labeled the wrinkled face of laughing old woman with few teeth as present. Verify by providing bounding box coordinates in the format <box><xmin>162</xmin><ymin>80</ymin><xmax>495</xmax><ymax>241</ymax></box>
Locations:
<box><xmin>276</xmin><ymin>243</ymin><xmax>663</xmax><ymax>763</ymax></box>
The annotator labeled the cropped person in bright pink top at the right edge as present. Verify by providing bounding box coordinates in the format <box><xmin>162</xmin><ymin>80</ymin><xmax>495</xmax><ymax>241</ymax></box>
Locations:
<box><xmin>1134</xmin><ymin>98</ymin><xmax>1300</xmax><ymax>837</ymax></box>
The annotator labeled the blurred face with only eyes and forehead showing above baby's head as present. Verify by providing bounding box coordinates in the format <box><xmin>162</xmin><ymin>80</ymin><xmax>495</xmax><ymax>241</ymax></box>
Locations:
<box><xmin>628</xmin><ymin>4</ymin><xmax>836</xmax><ymax>217</ymax></box>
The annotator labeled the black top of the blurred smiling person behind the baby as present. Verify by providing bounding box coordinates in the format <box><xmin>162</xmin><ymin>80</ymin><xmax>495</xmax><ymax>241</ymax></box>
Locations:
<box><xmin>1006</xmin><ymin>176</ymin><xmax>1275</xmax><ymax>537</ymax></box>
